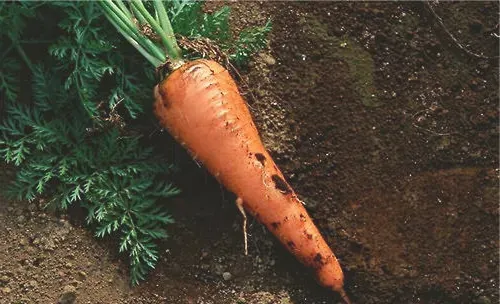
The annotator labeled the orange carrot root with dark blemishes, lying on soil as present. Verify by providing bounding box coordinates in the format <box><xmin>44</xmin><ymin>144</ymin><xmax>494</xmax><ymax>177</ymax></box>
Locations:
<box><xmin>154</xmin><ymin>59</ymin><xmax>348</xmax><ymax>301</ymax></box>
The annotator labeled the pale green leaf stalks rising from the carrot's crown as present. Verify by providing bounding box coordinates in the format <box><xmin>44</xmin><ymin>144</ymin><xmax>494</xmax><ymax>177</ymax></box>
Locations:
<box><xmin>100</xmin><ymin>0</ymin><xmax>182</xmax><ymax>67</ymax></box>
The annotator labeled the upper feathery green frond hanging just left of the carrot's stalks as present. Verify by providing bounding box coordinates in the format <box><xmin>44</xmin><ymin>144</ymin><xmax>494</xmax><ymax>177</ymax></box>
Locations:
<box><xmin>49</xmin><ymin>1</ymin><xmax>153</xmax><ymax>118</ymax></box>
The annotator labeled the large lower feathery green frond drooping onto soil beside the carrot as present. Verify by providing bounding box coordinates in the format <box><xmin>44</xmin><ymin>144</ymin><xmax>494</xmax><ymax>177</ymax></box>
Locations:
<box><xmin>0</xmin><ymin>62</ymin><xmax>178</xmax><ymax>283</ymax></box>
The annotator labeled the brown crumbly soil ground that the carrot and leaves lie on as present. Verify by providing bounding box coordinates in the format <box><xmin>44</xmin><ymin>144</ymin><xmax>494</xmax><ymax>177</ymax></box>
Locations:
<box><xmin>0</xmin><ymin>2</ymin><xmax>499</xmax><ymax>304</ymax></box>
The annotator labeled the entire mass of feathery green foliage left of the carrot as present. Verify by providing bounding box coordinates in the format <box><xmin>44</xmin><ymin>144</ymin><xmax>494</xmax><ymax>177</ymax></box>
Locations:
<box><xmin>0</xmin><ymin>2</ymin><xmax>179</xmax><ymax>284</ymax></box>
